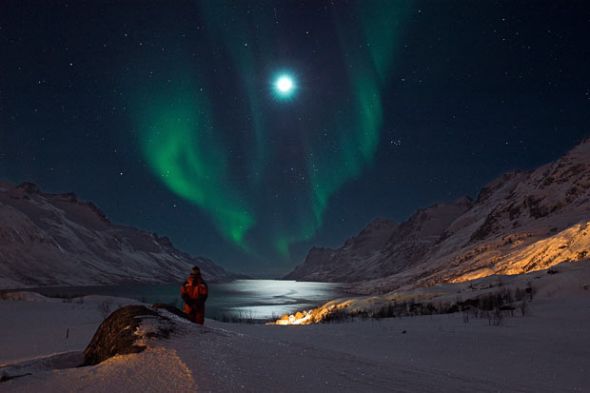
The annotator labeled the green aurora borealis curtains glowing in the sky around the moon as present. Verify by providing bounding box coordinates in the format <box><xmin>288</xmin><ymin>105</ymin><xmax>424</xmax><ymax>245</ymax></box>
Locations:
<box><xmin>134</xmin><ymin>1</ymin><xmax>407</xmax><ymax>257</ymax></box>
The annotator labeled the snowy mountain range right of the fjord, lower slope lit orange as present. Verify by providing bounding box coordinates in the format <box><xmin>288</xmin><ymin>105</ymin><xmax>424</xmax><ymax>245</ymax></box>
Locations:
<box><xmin>286</xmin><ymin>139</ymin><xmax>590</xmax><ymax>292</ymax></box>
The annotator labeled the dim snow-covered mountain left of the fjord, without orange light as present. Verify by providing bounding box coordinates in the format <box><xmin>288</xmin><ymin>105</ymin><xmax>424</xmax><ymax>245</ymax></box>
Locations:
<box><xmin>0</xmin><ymin>183</ymin><xmax>236</xmax><ymax>288</ymax></box>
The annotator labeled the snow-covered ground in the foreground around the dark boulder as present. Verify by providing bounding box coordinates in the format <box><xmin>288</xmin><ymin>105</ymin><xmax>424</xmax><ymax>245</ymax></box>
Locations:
<box><xmin>0</xmin><ymin>286</ymin><xmax>590</xmax><ymax>393</ymax></box>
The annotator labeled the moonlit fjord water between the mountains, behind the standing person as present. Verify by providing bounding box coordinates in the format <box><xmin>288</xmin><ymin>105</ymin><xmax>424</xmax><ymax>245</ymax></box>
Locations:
<box><xmin>37</xmin><ymin>280</ymin><xmax>340</xmax><ymax>320</ymax></box>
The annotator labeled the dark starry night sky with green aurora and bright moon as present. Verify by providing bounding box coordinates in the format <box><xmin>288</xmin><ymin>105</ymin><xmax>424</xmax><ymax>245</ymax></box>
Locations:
<box><xmin>0</xmin><ymin>0</ymin><xmax>590</xmax><ymax>274</ymax></box>
